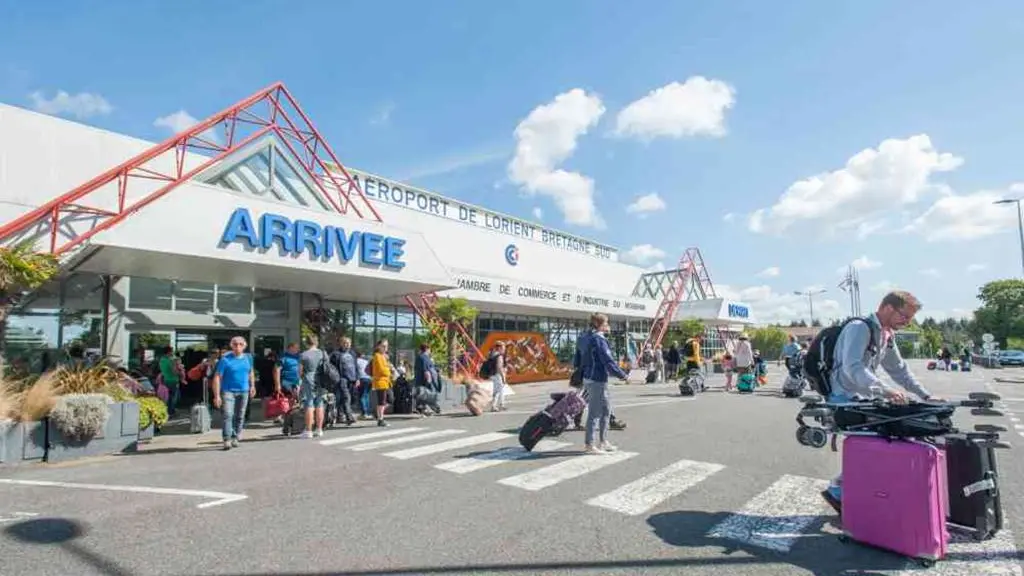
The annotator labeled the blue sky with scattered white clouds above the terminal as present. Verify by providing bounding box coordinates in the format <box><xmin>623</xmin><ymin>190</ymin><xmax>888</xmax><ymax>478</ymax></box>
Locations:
<box><xmin>0</xmin><ymin>0</ymin><xmax>1024</xmax><ymax>320</ymax></box>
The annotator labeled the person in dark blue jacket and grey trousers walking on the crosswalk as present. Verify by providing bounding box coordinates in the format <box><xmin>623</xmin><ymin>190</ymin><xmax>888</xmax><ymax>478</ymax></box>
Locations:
<box><xmin>572</xmin><ymin>314</ymin><xmax>627</xmax><ymax>454</ymax></box>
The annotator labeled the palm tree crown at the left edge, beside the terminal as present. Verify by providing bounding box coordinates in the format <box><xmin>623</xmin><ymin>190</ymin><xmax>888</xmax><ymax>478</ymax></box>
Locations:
<box><xmin>0</xmin><ymin>241</ymin><xmax>59</xmax><ymax>366</ymax></box>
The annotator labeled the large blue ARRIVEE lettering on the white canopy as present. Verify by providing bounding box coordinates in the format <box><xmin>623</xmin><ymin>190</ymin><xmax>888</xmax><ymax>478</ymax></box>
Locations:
<box><xmin>220</xmin><ymin>208</ymin><xmax>406</xmax><ymax>270</ymax></box>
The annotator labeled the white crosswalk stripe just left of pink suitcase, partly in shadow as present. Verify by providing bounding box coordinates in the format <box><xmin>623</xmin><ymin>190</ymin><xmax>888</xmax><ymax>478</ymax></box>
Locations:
<box><xmin>708</xmin><ymin>476</ymin><xmax>828</xmax><ymax>552</ymax></box>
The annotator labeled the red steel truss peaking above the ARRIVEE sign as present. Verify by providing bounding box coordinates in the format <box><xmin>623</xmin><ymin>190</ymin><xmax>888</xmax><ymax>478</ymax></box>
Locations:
<box><xmin>0</xmin><ymin>82</ymin><xmax>381</xmax><ymax>255</ymax></box>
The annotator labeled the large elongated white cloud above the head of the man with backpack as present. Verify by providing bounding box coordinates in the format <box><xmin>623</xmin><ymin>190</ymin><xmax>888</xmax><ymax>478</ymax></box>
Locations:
<box><xmin>748</xmin><ymin>134</ymin><xmax>964</xmax><ymax>239</ymax></box>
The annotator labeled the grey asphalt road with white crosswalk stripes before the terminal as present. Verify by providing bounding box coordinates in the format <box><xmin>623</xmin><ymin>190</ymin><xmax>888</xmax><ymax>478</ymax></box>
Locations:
<box><xmin>0</xmin><ymin>358</ymin><xmax>1024</xmax><ymax>576</ymax></box>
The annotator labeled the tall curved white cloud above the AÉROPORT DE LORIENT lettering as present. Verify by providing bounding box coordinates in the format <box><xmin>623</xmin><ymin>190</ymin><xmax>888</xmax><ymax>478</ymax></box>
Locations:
<box><xmin>508</xmin><ymin>88</ymin><xmax>604</xmax><ymax>228</ymax></box>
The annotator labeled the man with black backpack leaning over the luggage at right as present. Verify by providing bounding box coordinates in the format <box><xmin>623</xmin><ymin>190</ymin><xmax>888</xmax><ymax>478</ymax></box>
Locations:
<box><xmin>804</xmin><ymin>290</ymin><xmax>936</xmax><ymax>513</ymax></box>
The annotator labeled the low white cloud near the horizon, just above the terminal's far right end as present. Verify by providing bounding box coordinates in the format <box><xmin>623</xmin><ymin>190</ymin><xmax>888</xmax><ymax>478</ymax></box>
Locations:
<box><xmin>715</xmin><ymin>284</ymin><xmax>849</xmax><ymax>325</ymax></box>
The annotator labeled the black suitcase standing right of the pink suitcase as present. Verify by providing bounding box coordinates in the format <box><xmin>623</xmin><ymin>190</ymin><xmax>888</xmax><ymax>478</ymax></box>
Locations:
<box><xmin>946</xmin><ymin>436</ymin><xmax>1002</xmax><ymax>540</ymax></box>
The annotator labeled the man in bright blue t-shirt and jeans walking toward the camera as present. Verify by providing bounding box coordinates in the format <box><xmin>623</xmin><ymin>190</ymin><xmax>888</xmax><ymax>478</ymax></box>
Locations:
<box><xmin>213</xmin><ymin>336</ymin><xmax>256</xmax><ymax>450</ymax></box>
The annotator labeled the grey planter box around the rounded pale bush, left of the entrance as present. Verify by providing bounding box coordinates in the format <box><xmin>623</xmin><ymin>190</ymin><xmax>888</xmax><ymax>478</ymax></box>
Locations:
<box><xmin>46</xmin><ymin>402</ymin><xmax>139</xmax><ymax>462</ymax></box>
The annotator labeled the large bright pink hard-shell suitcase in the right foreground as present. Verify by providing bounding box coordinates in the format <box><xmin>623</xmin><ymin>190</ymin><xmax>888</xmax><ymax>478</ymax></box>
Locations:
<box><xmin>843</xmin><ymin>436</ymin><xmax>949</xmax><ymax>566</ymax></box>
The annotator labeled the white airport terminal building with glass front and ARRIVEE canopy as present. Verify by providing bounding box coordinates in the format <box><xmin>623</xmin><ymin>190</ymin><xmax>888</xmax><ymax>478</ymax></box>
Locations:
<box><xmin>0</xmin><ymin>87</ymin><xmax>755</xmax><ymax>381</ymax></box>
